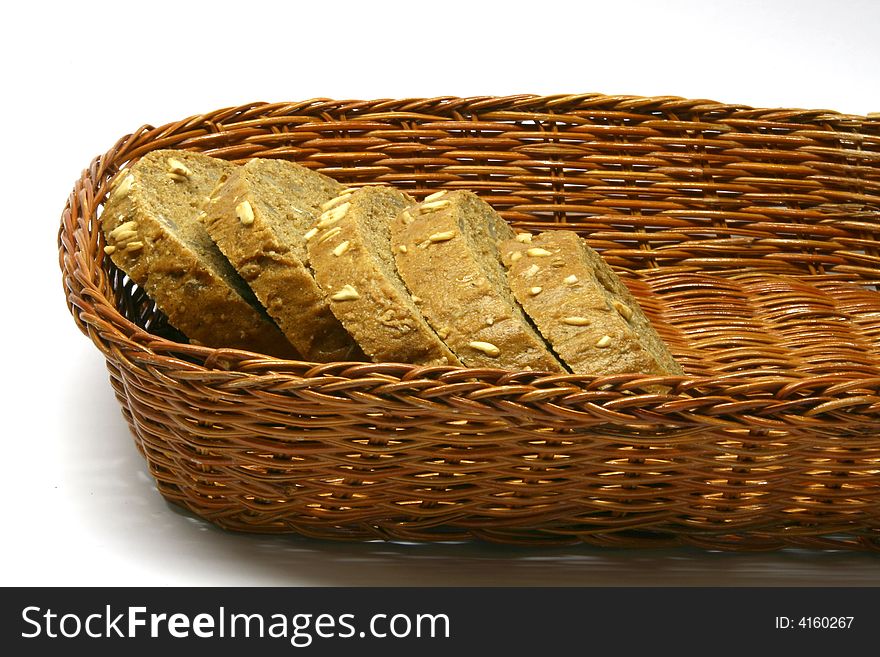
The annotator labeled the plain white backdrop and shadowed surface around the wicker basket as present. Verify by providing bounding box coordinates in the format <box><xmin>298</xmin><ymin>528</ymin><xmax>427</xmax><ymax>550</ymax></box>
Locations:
<box><xmin>0</xmin><ymin>0</ymin><xmax>880</xmax><ymax>586</ymax></box>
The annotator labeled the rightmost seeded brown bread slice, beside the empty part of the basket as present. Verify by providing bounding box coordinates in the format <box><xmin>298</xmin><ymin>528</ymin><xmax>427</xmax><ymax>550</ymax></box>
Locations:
<box><xmin>500</xmin><ymin>230</ymin><xmax>683</xmax><ymax>375</ymax></box>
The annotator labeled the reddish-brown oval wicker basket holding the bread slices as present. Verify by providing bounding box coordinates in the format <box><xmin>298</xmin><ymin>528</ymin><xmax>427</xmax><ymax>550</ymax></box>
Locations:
<box><xmin>59</xmin><ymin>94</ymin><xmax>880</xmax><ymax>550</ymax></box>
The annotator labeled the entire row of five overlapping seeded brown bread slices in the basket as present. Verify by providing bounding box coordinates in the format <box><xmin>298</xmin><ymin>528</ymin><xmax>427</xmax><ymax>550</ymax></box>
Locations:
<box><xmin>99</xmin><ymin>150</ymin><xmax>683</xmax><ymax>375</ymax></box>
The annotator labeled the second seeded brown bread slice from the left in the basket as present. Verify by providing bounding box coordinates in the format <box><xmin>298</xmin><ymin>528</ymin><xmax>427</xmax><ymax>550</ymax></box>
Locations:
<box><xmin>202</xmin><ymin>158</ymin><xmax>364</xmax><ymax>362</ymax></box>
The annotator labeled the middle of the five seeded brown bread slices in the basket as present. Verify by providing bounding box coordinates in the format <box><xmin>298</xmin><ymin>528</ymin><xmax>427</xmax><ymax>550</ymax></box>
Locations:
<box><xmin>307</xmin><ymin>186</ymin><xmax>460</xmax><ymax>365</ymax></box>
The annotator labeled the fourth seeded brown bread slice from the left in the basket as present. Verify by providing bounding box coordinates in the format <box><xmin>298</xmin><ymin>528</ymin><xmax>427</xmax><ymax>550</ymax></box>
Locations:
<box><xmin>391</xmin><ymin>191</ymin><xmax>565</xmax><ymax>372</ymax></box>
